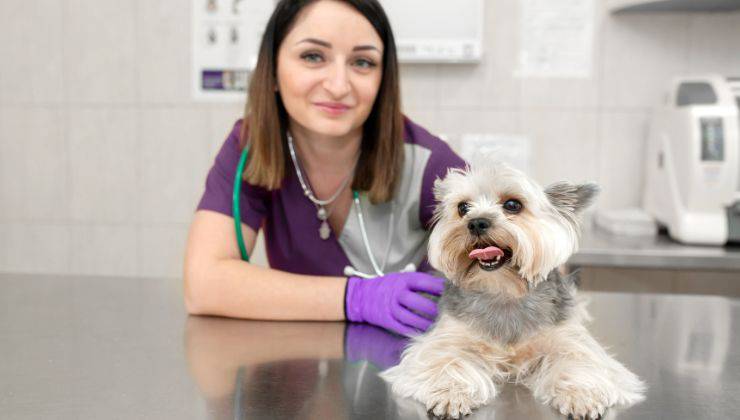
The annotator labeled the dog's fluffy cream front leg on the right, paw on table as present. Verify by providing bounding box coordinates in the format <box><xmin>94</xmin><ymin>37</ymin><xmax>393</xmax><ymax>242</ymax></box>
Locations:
<box><xmin>519</xmin><ymin>312</ymin><xmax>645</xmax><ymax>419</ymax></box>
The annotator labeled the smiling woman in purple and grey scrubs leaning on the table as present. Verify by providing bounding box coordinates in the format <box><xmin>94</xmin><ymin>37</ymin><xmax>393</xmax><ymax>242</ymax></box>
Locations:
<box><xmin>184</xmin><ymin>0</ymin><xmax>464</xmax><ymax>335</ymax></box>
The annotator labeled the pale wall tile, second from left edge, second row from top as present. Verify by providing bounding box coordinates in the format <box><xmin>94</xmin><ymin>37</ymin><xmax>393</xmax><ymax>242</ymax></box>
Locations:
<box><xmin>68</xmin><ymin>107</ymin><xmax>138</xmax><ymax>224</ymax></box>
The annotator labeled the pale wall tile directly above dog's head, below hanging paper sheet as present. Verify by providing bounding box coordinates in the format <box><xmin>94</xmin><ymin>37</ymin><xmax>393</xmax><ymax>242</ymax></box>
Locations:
<box><xmin>522</xmin><ymin>110</ymin><xmax>600</xmax><ymax>186</ymax></box>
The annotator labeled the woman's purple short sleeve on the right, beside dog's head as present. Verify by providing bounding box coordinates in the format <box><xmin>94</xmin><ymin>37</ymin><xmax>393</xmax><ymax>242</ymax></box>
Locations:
<box><xmin>419</xmin><ymin>139</ymin><xmax>466</xmax><ymax>229</ymax></box>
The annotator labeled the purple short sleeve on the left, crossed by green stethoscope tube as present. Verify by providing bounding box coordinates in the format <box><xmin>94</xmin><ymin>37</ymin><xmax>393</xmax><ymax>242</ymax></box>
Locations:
<box><xmin>197</xmin><ymin>120</ymin><xmax>269</xmax><ymax>232</ymax></box>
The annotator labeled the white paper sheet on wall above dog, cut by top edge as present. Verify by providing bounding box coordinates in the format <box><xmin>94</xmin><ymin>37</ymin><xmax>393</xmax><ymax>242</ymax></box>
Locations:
<box><xmin>516</xmin><ymin>0</ymin><xmax>594</xmax><ymax>78</ymax></box>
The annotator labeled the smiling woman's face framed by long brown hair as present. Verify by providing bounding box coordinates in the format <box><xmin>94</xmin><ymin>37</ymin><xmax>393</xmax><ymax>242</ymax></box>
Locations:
<box><xmin>277</xmin><ymin>0</ymin><xmax>383</xmax><ymax>141</ymax></box>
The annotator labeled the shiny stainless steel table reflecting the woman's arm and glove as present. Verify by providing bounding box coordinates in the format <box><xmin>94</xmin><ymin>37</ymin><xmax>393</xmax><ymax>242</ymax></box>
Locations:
<box><xmin>0</xmin><ymin>274</ymin><xmax>740</xmax><ymax>419</ymax></box>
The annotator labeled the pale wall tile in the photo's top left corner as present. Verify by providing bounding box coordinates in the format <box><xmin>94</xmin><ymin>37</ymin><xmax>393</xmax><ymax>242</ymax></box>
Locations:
<box><xmin>0</xmin><ymin>0</ymin><xmax>64</xmax><ymax>104</ymax></box>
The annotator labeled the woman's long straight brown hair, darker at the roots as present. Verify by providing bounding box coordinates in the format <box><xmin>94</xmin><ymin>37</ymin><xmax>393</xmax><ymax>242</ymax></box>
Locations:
<box><xmin>240</xmin><ymin>0</ymin><xmax>404</xmax><ymax>203</ymax></box>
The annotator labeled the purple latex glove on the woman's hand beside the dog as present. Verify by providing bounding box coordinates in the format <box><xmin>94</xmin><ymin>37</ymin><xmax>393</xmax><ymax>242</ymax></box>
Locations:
<box><xmin>344</xmin><ymin>272</ymin><xmax>444</xmax><ymax>337</ymax></box>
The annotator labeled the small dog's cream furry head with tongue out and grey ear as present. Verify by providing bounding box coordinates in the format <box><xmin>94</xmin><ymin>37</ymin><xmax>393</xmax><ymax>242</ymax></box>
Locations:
<box><xmin>429</xmin><ymin>163</ymin><xmax>598</xmax><ymax>294</ymax></box>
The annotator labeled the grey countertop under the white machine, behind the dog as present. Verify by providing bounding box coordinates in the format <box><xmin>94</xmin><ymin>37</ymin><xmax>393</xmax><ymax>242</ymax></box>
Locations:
<box><xmin>568</xmin><ymin>226</ymin><xmax>740</xmax><ymax>270</ymax></box>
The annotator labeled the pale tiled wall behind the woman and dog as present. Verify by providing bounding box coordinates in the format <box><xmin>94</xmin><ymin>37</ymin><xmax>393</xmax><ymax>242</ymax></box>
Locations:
<box><xmin>0</xmin><ymin>0</ymin><xmax>740</xmax><ymax>276</ymax></box>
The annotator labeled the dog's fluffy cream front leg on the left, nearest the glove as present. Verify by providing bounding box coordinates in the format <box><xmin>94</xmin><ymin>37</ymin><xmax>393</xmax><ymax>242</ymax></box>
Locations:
<box><xmin>380</xmin><ymin>315</ymin><xmax>506</xmax><ymax>418</ymax></box>
